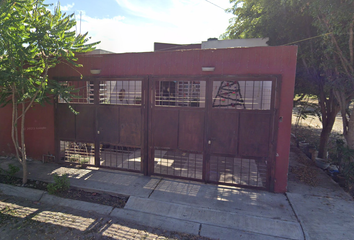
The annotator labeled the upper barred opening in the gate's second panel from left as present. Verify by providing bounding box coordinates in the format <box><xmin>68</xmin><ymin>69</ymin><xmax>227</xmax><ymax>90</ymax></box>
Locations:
<box><xmin>100</xmin><ymin>81</ymin><xmax>142</xmax><ymax>105</ymax></box>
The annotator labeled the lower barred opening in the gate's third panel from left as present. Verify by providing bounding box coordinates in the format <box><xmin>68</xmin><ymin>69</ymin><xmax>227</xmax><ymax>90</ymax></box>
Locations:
<box><xmin>154</xmin><ymin>149</ymin><xmax>203</xmax><ymax>179</ymax></box>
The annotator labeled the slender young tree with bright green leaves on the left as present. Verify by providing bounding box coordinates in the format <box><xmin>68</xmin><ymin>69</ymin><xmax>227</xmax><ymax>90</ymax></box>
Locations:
<box><xmin>0</xmin><ymin>0</ymin><xmax>98</xmax><ymax>184</ymax></box>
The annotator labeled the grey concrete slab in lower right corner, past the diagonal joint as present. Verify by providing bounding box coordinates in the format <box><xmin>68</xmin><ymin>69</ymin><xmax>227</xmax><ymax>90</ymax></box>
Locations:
<box><xmin>286</xmin><ymin>151</ymin><xmax>354</xmax><ymax>240</ymax></box>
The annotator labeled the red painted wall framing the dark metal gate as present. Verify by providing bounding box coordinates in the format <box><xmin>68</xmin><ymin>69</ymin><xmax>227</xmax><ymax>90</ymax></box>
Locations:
<box><xmin>0</xmin><ymin>46</ymin><xmax>297</xmax><ymax>192</ymax></box>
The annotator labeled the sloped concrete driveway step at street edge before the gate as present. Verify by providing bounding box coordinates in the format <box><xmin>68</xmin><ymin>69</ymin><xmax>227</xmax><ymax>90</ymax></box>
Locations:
<box><xmin>124</xmin><ymin>196</ymin><xmax>303</xmax><ymax>239</ymax></box>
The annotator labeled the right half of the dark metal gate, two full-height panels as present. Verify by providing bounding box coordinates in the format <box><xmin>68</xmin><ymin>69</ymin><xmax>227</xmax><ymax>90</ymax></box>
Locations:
<box><xmin>148</xmin><ymin>76</ymin><xmax>280</xmax><ymax>189</ymax></box>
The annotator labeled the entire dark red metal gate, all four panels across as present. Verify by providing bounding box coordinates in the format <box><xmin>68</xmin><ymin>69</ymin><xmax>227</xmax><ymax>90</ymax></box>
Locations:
<box><xmin>56</xmin><ymin>76</ymin><xmax>280</xmax><ymax>190</ymax></box>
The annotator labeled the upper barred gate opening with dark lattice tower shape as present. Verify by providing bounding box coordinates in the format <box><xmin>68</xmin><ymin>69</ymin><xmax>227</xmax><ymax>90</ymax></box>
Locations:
<box><xmin>212</xmin><ymin>81</ymin><xmax>272</xmax><ymax>110</ymax></box>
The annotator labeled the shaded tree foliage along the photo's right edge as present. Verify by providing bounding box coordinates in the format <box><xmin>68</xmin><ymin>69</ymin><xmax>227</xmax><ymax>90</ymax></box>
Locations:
<box><xmin>306</xmin><ymin>0</ymin><xmax>354</xmax><ymax>149</ymax></box>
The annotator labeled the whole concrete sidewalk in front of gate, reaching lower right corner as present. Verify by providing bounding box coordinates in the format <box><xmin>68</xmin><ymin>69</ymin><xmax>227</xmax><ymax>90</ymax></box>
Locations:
<box><xmin>0</xmin><ymin>149</ymin><xmax>354</xmax><ymax>239</ymax></box>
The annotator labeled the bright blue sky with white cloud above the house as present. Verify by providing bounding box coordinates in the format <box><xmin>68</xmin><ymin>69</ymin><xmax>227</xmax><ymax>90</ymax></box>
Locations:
<box><xmin>45</xmin><ymin>0</ymin><xmax>233</xmax><ymax>53</ymax></box>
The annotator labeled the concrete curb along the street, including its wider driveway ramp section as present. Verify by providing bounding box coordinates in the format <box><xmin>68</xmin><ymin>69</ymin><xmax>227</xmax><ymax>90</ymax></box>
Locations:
<box><xmin>0</xmin><ymin>184</ymin><xmax>303</xmax><ymax>240</ymax></box>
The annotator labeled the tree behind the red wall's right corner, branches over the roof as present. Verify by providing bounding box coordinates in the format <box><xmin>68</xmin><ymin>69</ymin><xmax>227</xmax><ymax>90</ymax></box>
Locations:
<box><xmin>222</xmin><ymin>0</ymin><xmax>340</xmax><ymax>158</ymax></box>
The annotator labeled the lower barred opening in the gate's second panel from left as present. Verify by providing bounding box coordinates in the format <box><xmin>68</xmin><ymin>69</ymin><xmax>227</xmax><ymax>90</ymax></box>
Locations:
<box><xmin>100</xmin><ymin>144</ymin><xmax>141</xmax><ymax>171</ymax></box>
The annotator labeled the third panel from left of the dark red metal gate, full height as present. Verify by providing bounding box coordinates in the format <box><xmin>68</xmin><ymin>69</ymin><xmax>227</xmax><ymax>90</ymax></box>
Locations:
<box><xmin>149</xmin><ymin>78</ymin><xmax>206</xmax><ymax>180</ymax></box>
